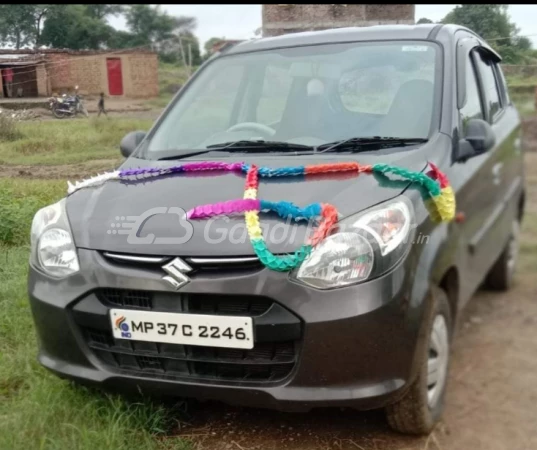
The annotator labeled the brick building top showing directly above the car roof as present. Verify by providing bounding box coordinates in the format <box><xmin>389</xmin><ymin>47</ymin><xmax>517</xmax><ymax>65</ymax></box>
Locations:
<box><xmin>263</xmin><ymin>4</ymin><xmax>415</xmax><ymax>37</ymax></box>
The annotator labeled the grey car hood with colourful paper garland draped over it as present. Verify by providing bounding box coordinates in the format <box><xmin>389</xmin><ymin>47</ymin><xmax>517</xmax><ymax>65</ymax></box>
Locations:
<box><xmin>67</xmin><ymin>145</ymin><xmax>440</xmax><ymax>257</ymax></box>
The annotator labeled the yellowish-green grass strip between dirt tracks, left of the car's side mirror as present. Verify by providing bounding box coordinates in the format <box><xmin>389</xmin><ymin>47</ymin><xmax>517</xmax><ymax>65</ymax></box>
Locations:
<box><xmin>0</xmin><ymin>118</ymin><xmax>153</xmax><ymax>165</ymax></box>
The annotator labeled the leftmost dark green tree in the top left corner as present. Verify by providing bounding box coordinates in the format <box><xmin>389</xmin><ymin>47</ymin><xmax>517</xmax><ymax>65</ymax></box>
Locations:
<box><xmin>0</xmin><ymin>4</ymin><xmax>52</xmax><ymax>49</ymax></box>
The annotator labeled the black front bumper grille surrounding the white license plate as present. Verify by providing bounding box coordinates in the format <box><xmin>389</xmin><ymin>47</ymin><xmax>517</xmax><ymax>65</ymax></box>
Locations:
<box><xmin>73</xmin><ymin>288</ymin><xmax>301</xmax><ymax>383</ymax></box>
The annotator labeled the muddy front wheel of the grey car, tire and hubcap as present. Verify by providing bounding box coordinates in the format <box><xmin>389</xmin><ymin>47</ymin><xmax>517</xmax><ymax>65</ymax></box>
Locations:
<box><xmin>385</xmin><ymin>287</ymin><xmax>452</xmax><ymax>435</ymax></box>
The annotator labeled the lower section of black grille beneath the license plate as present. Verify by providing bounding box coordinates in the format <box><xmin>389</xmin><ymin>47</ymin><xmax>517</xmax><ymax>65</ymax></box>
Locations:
<box><xmin>83</xmin><ymin>327</ymin><xmax>296</xmax><ymax>382</ymax></box>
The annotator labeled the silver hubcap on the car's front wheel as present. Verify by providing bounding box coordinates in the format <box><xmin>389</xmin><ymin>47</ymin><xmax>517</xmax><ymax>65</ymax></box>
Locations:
<box><xmin>427</xmin><ymin>315</ymin><xmax>449</xmax><ymax>408</ymax></box>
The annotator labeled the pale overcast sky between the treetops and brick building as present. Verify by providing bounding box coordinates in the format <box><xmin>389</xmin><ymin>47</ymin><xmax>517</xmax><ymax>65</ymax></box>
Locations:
<box><xmin>109</xmin><ymin>5</ymin><xmax>537</xmax><ymax>49</ymax></box>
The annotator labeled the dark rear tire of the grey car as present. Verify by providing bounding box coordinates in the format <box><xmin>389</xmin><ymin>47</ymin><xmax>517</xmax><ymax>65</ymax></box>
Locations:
<box><xmin>485</xmin><ymin>218</ymin><xmax>520</xmax><ymax>291</ymax></box>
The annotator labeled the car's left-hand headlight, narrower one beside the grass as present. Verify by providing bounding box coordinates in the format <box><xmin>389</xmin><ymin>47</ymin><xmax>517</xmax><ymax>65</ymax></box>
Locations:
<box><xmin>30</xmin><ymin>199</ymin><xmax>80</xmax><ymax>278</ymax></box>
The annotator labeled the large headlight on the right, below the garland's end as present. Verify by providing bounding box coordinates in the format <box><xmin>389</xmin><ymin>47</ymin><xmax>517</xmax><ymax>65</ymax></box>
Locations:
<box><xmin>291</xmin><ymin>197</ymin><xmax>414</xmax><ymax>289</ymax></box>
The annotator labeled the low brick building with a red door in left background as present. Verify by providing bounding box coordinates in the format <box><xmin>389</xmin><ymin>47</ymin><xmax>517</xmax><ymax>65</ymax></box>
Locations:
<box><xmin>0</xmin><ymin>49</ymin><xmax>159</xmax><ymax>98</ymax></box>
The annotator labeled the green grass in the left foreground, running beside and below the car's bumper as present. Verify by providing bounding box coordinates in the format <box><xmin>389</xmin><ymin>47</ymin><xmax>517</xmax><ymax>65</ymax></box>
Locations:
<box><xmin>0</xmin><ymin>179</ymin><xmax>190</xmax><ymax>450</ymax></box>
